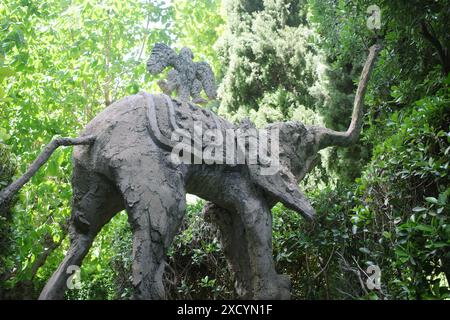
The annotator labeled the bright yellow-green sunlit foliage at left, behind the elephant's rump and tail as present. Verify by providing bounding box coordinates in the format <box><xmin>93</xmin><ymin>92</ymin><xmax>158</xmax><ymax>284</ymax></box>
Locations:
<box><xmin>0</xmin><ymin>0</ymin><xmax>216</xmax><ymax>297</ymax></box>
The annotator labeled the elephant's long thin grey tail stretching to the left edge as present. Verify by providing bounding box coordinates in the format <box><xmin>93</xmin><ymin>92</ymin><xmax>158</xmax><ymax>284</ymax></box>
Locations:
<box><xmin>0</xmin><ymin>136</ymin><xmax>95</xmax><ymax>205</ymax></box>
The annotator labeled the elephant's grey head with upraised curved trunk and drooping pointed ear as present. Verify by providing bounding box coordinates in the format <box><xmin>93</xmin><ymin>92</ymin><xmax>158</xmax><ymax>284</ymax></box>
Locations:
<box><xmin>250</xmin><ymin>45</ymin><xmax>380</xmax><ymax>218</ymax></box>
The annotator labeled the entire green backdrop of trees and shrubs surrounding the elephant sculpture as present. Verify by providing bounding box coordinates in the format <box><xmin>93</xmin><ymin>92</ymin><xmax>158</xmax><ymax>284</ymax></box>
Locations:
<box><xmin>0</xmin><ymin>0</ymin><xmax>450</xmax><ymax>299</ymax></box>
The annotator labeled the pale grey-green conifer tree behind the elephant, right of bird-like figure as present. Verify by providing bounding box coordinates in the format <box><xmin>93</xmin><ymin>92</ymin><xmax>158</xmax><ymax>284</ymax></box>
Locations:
<box><xmin>218</xmin><ymin>0</ymin><xmax>322</xmax><ymax>126</ymax></box>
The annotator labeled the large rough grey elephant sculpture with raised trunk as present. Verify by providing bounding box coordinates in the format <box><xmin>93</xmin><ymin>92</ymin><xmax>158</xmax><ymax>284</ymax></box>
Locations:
<box><xmin>39</xmin><ymin>46</ymin><xmax>379</xmax><ymax>299</ymax></box>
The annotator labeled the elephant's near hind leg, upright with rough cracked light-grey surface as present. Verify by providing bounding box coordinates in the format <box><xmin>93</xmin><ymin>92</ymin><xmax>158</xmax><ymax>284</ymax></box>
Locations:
<box><xmin>117</xmin><ymin>154</ymin><xmax>186</xmax><ymax>300</ymax></box>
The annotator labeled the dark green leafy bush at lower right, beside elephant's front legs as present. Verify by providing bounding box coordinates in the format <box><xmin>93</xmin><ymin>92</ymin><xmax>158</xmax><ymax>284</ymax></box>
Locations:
<box><xmin>274</xmin><ymin>80</ymin><xmax>450</xmax><ymax>299</ymax></box>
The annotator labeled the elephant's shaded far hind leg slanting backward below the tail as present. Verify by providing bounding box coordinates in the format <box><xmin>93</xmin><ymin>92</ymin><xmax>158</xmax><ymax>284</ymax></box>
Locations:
<box><xmin>39</xmin><ymin>166</ymin><xmax>123</xmax><ymax>300</ymax></box>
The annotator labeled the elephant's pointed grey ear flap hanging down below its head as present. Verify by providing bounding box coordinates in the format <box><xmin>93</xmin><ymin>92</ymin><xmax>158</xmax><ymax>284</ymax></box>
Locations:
<box><xmin>248</xmin><ymin>165</ymin><xmax>316</xmax><ymax>220</ymax></box>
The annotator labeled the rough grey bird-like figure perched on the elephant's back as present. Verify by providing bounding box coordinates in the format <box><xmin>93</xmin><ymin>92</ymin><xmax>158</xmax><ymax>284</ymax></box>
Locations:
<box><xmin>147</xmin><ymin>43</ymin><xmax>217</xmax><ymax>104</ymax></box>
